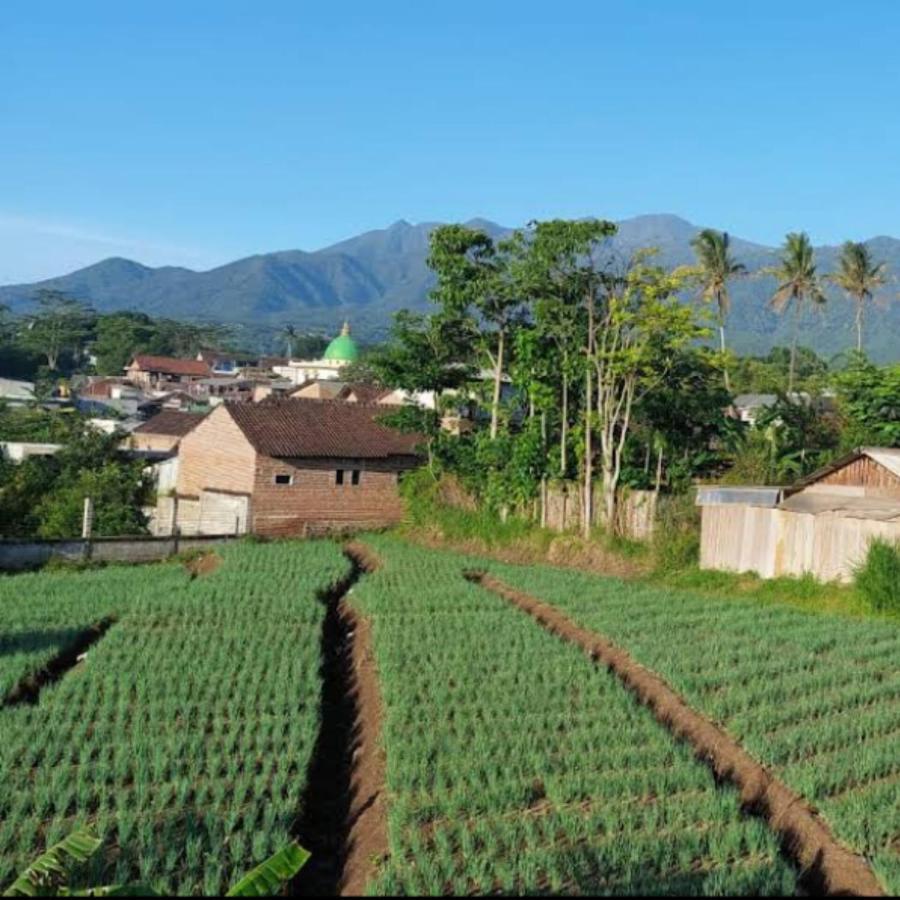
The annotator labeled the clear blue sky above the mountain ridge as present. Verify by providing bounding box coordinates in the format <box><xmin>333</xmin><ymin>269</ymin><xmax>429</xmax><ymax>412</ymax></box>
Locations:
<box><xmin>0</xmin><ymin>0</ymin><xmax>900</xmax><ymax>283</ymax></box>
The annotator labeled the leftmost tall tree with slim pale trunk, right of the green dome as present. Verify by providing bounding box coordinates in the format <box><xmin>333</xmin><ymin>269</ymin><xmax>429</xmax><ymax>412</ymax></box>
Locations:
<box><xmin>428</xmin><ymin>225</ymin><xmax>521</xmax><ymax>440</ymax></box>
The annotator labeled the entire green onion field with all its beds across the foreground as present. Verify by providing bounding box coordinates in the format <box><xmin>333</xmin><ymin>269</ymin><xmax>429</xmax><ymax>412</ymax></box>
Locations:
<box><xmin>0</xmin><ymin>536</ymin><xmax>900</xmax><ymax>896</ymax></box>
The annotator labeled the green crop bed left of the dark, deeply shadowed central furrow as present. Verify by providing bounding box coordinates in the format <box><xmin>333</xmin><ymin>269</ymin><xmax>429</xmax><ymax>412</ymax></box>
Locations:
<box><xmin>0</xmin><ymin>543</ymin><xmax>349</xmax><ymax>894</ymax></box>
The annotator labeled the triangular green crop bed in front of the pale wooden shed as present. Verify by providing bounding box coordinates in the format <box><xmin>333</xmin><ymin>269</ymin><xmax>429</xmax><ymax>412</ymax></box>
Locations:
<box><xmin>482</xmin><ymin>562</ymin><xmax>900</xmax><ymax>894</ymax></box>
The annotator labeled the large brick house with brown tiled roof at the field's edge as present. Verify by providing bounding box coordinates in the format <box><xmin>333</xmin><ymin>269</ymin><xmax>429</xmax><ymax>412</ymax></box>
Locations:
<box><xmin>172</xmin><ymin>399</ymin><xmax>421</xmax><ymax>536</ymax></box>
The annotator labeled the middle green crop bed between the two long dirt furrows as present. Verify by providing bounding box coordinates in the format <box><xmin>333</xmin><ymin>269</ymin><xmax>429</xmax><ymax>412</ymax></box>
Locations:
<box><xmin>352</xmin><ymin>537</ymin><xmax>796</xmax><ymax>895</ymax></box>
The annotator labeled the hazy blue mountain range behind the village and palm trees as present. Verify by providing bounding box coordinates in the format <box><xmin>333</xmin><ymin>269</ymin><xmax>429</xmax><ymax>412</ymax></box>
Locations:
<box><xmin>0</xmin><ymin>215</ymin><xmax>900</xmax><ymax>360</ymax></box>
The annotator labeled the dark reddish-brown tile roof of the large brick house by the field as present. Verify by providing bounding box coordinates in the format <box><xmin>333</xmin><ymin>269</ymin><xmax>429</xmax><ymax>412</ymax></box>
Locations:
<box><xmin>227</xmin><ymin>399</ymin><xmax>422</xmax><ymax>459</ymax></box>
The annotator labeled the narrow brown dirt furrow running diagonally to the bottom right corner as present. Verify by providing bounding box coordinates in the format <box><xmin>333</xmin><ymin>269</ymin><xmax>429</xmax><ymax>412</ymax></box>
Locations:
<box><xmin>466</xmin><ymin>572</ymin><xmax>885</xmax><ymax>897</ymax></box>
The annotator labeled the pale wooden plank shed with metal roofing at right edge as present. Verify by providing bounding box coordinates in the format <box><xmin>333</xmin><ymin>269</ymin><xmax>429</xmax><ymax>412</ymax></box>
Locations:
<box><xmin>697</xmin><ymin>447</ymin><xmax>900</xmax><ymax>581</ymax></box>
